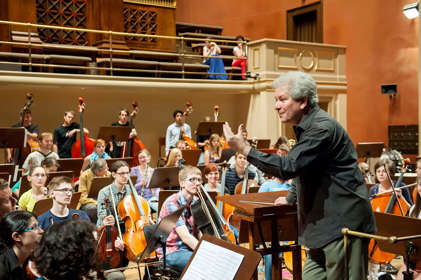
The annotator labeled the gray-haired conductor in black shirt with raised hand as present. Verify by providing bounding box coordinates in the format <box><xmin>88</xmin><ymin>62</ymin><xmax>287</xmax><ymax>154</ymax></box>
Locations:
<box><xmin>224</xmin><ymin>71</ymin><xmax>376</xmax><ymax>280</ymax></box>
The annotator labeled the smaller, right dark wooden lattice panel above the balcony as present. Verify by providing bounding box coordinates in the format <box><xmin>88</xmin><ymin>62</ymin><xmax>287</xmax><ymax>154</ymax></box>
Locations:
<box><xmin>123</xmin><ymin>7</ymin><xmax>158</xmax><ymax>43</ymax></box>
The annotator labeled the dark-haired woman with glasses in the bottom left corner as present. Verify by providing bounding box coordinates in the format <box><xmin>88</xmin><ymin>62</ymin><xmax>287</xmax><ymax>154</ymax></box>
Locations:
<box><xmin>0</xmin><ymin>211</ymin><xmax>43</xmax><ymax>280</ymax></box>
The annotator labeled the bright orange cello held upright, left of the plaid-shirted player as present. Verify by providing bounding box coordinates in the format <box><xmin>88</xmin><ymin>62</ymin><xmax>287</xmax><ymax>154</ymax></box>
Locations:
<box><xmin>118</xmin><ymin>177</ymin><xmax>153</xmax><ymax>261</ymax></box>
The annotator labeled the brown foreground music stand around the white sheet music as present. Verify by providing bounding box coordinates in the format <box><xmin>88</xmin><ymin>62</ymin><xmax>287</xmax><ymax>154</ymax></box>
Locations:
<box><xmin>180</xmin><ymin>234</ymin><xmax>262</xmax><ymax>280</ymax></box>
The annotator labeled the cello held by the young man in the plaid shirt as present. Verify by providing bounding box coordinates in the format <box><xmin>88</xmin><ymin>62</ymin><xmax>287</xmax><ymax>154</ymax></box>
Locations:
<box><xmin>191</xmin><ymin>186</ymin><xmax>237</xmax><ymax>244</ymax></box>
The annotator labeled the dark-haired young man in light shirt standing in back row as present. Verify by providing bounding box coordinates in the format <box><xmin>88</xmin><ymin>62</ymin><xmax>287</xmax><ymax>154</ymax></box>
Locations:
<box><xmin>165</xmin><ymin>110</ymin><xmax>191</xmax><ymax>158</ymax></box>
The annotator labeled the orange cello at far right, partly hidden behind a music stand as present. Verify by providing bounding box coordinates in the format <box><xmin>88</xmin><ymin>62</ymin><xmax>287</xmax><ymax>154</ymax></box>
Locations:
<box><xmin>368</xmin><ymin>159</ymin><xmax>409</xmax><ymax>263</ymax></box>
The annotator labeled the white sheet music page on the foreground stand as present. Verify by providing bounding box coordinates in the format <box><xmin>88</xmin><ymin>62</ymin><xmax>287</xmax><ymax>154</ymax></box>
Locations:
<box><xmin>182</xmin><ymin>240</ymin><xmax>244</xmax><ymax>280</ymax></box>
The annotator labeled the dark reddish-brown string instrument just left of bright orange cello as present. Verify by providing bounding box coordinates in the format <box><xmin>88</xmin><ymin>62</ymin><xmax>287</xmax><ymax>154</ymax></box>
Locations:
<box><xmin>98</xmin><ymin>197</ymin><xmax>121</xmax><ymax>267</ymax></box>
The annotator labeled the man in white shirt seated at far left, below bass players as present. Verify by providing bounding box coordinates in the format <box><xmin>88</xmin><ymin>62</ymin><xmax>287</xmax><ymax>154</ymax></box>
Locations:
<box><xmin>22</xmin><ymin>132</ymin><xmax>59</xmax><ymax>170</ymax></box>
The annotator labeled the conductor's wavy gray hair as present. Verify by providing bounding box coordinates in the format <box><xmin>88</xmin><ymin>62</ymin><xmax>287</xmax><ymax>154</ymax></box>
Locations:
<box><xmin>272</xmin><ymin>71</ymin><xmax>319</xmax><ymax>107</ymax></box>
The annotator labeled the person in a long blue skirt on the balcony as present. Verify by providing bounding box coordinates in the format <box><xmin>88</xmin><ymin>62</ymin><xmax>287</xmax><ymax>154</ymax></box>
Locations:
<box><xmin>203</xmin><ymin>38</ymin><xmax>228</xmax><ymax>80</ymax></box>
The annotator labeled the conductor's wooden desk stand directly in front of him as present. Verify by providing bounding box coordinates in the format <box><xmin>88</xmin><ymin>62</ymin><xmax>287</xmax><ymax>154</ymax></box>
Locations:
<box><xmin>217</xmin><ymin>191</ymin><xmax>302</xmax><ymax>280</ymax></box>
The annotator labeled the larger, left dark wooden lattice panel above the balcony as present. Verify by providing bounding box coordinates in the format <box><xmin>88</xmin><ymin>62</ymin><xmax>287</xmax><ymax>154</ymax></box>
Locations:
<box><xmin>36</xmin><ymin>0</ymin><xmax>88</xmax><ymax>45</ymax></box>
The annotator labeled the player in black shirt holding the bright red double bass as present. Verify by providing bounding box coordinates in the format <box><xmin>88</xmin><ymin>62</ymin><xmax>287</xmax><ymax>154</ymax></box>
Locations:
<box><xmin>53</xmin><ymin>111</ymin><xmax>88</xmax><ymax>158</ymax></box>
